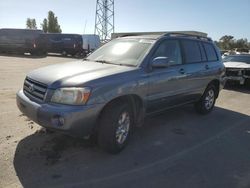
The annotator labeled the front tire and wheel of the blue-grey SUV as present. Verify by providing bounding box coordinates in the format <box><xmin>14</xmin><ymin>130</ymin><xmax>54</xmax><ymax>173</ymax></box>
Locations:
<box><xmin>97</xmin><ymin>101</ymin><xmax>133</xmax><ymax>154</ymax></box>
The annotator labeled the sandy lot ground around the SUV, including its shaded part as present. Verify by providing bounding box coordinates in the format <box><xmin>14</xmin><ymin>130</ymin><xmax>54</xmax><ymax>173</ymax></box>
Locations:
<box><xmin>0</xmin><ymin>55</ymin><xmax>250</xmax><ymax>188</ymax></box>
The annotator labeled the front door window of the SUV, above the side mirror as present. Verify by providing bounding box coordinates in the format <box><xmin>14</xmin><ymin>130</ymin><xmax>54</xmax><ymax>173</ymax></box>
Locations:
<box><xmin>153</xmin><ymin>40</ymin><xmax>182</xmax><ymax>65</ymax></box>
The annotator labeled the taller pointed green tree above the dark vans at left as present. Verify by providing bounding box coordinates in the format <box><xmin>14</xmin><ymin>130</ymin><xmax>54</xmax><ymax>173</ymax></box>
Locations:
<box><xmin>41</xmin><ymin>11</ymin><xmax>62</xmax><ymax>33</ymax></box>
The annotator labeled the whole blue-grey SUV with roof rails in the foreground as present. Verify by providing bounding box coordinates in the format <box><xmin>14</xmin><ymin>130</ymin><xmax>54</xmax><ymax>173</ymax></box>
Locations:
<box><xmin>16</xmin><ymin>32</ymin><xmax>225</xmax><ymax>153</ymax></box>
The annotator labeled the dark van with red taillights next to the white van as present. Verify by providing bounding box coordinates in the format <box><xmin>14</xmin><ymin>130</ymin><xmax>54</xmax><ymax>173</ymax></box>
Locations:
<box><xmin>44</xmin><ymin>33</ymin><xmax>83</xmax><ymax>56</ymax></box>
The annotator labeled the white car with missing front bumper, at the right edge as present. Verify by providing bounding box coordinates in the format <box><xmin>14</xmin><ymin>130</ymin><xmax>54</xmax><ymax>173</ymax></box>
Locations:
<box><xmin>223</xmin><ymin>54</ymin><xmax>250</xmax><ymax>85</ymax></box>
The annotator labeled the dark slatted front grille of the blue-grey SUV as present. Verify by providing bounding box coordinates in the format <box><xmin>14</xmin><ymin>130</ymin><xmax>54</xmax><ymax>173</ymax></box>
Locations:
<box><xmin>23</xmin><ymin>78</ymin><xmax>47</xmax><ymax>101</ymax></box>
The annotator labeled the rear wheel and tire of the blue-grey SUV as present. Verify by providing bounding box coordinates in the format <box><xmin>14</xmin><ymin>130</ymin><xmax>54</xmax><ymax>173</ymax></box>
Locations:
<box><xmin>195</xmin><ymin>85</ymin><xmax>217</xmax><ymax>114</ymax></box>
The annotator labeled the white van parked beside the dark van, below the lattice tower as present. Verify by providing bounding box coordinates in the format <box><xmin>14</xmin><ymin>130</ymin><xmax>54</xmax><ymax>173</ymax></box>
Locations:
<box><xmin>82</xmin><ymin>34</ymin><xmax>101</xmax><ymax>54</ymax></box>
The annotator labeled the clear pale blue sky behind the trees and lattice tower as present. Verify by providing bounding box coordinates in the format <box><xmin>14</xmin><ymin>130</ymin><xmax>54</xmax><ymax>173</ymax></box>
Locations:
<box><xmin>0</xmin><ymin>0</ymin><xmax>250</xmax><ymax>41</ymax></box>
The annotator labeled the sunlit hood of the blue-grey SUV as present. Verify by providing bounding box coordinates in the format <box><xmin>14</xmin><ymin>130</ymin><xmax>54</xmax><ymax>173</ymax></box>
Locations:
<box><xmin>27</xmin><ymin>61</ymin><xmax>135</xmax><ymax>88</ymax></box>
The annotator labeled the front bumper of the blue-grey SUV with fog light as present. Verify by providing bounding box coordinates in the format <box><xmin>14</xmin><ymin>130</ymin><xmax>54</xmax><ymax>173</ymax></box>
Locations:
<box><xmin>16</xmin><ymin>90</ymin><xmax>104</xmax><ymax>137</ymax></box>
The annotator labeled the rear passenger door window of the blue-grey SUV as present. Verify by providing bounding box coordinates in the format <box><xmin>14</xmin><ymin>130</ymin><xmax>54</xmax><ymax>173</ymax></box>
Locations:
<box><xmin>182</xmin><ymin>40</ymin><xmax>202</xmax><ymax>63</ymax></box>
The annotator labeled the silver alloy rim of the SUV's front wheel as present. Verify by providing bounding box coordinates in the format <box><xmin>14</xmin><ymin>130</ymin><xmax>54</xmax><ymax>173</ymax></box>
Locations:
<box><xmin>116</xmin><ymin>112</ymin><xmax>130</xmax><ymax>144</ymax></box>
